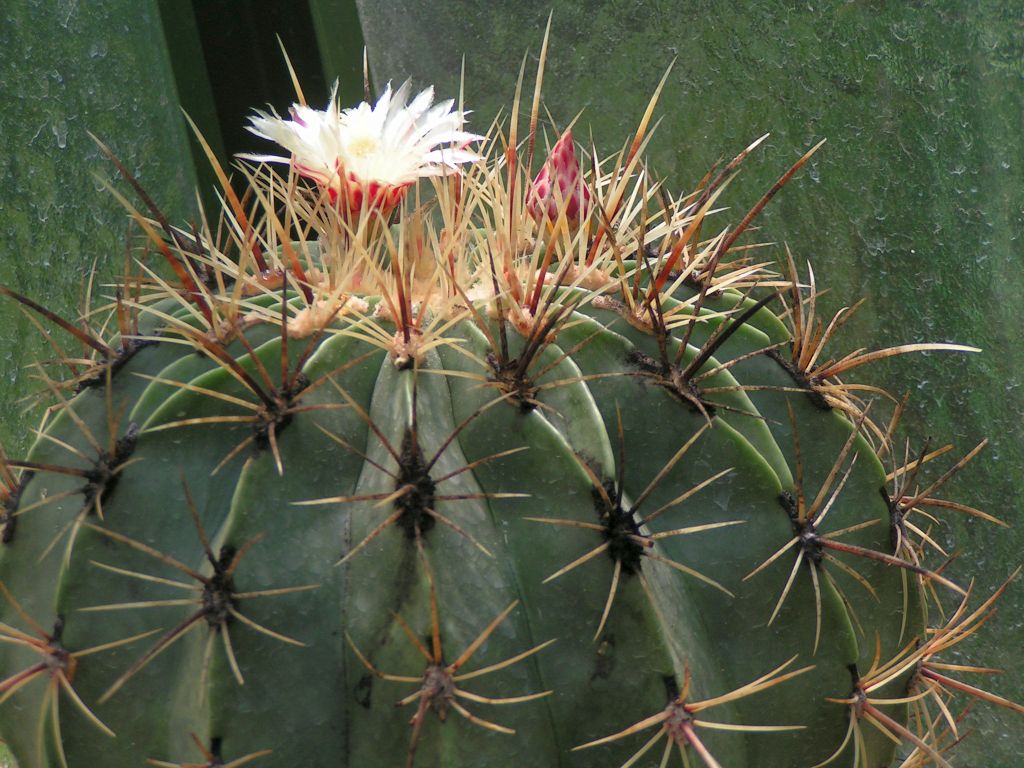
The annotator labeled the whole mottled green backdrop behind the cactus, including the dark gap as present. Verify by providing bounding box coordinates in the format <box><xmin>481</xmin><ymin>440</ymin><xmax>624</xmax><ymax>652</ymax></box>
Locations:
<box><xmin>0</xmin><ymin>0</ymin><xmax>1024</xmax><ymax>768</ymax></box>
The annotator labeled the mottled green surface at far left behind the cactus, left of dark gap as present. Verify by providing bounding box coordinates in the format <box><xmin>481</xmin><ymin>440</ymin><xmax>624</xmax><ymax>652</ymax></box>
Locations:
<box><xmin>0</xmin><ymin>0</ymin><xmax>196</xmax><ymax>452</ymax></box>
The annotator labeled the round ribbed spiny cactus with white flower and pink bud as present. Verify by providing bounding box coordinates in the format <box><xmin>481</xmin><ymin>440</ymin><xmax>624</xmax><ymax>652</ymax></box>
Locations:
<box><xmin>0</xmin><ymin>51</ymin><xmax>1020</xmax><ymax>768</ymax></box>
